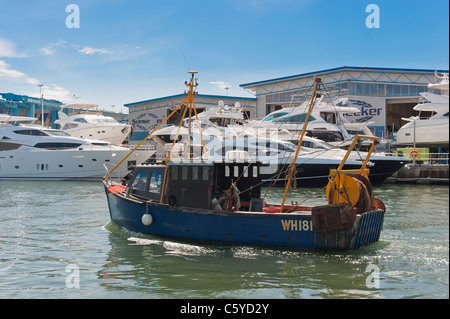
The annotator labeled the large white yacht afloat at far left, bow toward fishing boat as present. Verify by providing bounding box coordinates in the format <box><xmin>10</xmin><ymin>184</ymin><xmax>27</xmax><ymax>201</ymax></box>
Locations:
<box><xmin>0</xmin><ymin>116</ymin><xmax>154</xmax><ymax>180</ymax></box>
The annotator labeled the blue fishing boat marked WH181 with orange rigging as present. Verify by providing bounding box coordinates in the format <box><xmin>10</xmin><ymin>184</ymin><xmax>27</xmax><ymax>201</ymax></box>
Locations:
<box><xmin>103</xmin><ymin>72</ymin><xmax>386</xmax><ymax>250</ymax></box>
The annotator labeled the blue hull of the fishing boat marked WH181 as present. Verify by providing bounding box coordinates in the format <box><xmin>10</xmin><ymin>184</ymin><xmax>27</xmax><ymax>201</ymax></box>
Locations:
<box><xmin>106</xmin><ymin>185</ymin><xmax>384</xmax><ymax>250</ymax></box>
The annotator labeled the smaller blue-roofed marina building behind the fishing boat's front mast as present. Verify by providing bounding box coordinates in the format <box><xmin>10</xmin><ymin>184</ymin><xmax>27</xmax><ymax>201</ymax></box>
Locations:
<box><xmin>125</xmin><ymin>94</ymin><xmax>256</xmax><ymax>143</ymax></box>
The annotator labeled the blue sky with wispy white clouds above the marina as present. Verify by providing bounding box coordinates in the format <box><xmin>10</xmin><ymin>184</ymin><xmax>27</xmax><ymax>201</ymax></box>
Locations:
<box><xmin>0</xmin><ymin>0</ymin><xmax>449</xmax><ymax>112</ymax></box>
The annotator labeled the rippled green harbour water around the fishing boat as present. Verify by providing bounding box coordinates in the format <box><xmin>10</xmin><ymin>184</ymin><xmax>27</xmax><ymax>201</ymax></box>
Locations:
<box><xmin>0</xmin><ymin>181</ymin><xmax>449</xmax><ymax>299</ymax></box>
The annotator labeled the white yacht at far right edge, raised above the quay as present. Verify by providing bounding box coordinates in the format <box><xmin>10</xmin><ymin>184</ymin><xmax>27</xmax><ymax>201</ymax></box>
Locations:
<box><xmin>397</xmin><ymin>74</ymin><xmax>449</xmax><ymax>150</ymax></box>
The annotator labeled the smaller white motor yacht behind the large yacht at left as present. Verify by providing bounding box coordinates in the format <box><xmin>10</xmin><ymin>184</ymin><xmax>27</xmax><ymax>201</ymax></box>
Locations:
<box><xmin>55</xmin><ymin>104</ymin><xmax>131</xmax><ymax>145</ymax></box>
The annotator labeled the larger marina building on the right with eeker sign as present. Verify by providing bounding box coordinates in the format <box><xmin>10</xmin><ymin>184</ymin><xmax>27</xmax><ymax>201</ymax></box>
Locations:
<box><xmin>240</xmin><ymin>66</ymin><xmax>449</xmax><ymax>137</ymax></box>
